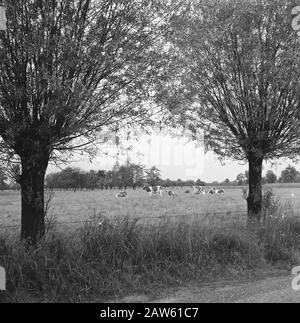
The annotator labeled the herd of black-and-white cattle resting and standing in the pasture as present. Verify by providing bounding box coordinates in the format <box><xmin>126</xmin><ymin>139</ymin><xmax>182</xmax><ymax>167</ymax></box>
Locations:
<box><xmin>116</xmin><ymin>185</ymin><xmax>225</xmax><ymax>198</ymax></box>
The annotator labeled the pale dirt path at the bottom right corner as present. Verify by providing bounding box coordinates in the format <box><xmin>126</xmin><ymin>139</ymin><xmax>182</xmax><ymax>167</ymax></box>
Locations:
<box><xmin>113</xmin><ymin>273</ymin><xmax>300</xmax><ymax>303</ymax></box>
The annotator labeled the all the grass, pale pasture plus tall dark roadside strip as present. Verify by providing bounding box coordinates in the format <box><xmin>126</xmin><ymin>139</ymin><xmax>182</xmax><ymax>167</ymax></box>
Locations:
<box><xmin>0</xmin><ymin>186</ymin><xmax>300</xmax><ymax>302</ymax></box>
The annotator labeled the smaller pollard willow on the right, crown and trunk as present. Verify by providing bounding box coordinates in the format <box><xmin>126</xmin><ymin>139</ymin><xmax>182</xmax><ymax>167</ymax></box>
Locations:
<box><xmin>158</xmin><ymin>0</ymin><xmax>300</xmax><ymax>223</ymax></box>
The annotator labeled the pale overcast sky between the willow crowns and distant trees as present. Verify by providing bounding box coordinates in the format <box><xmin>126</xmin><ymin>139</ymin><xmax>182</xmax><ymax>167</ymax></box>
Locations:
<box><xmin>48</xmin><ymin>135</ymin><xmax>297</xmax><ymax>182</ymax></box>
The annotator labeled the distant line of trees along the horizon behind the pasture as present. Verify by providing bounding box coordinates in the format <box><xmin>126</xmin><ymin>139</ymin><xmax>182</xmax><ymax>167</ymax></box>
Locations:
<box><xmin>0</xmin><ymin>161</ymin><xmax>300</xmax><ymax>191</ymax></box>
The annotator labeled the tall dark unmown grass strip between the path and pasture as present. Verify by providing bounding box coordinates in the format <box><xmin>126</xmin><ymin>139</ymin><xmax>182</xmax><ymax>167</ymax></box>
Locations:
<box><xmin>0</xmin><ymin>191</ymin><xmax>300</xmax><ymax>302</ymax></box>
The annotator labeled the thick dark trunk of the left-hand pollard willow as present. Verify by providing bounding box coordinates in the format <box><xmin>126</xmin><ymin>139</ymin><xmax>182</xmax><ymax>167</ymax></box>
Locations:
<box><xmin>20</xmin><ymin>155</ymin><xmax>49</xmax><ymax>245</ymax></box>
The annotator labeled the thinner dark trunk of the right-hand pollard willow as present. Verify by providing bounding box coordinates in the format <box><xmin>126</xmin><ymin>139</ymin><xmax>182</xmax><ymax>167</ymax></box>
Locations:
<box><xmin>247</xmin><ymin>156</ymin><xmax>263</xmax><ymax>226</ymax></box>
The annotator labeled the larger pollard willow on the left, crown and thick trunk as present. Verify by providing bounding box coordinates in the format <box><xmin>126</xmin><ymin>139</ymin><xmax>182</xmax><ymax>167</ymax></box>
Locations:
<box><xmin>0</xmin><ymin>0</ymin><xmax>178</xmax><ymax>244</ymax></box>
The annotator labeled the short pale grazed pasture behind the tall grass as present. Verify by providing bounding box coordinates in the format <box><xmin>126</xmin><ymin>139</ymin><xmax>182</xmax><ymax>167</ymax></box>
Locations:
<box><xmin>0</xmin><ymin>184</ymin><xmax>300</xmax><ymax>227</ymax></box>
